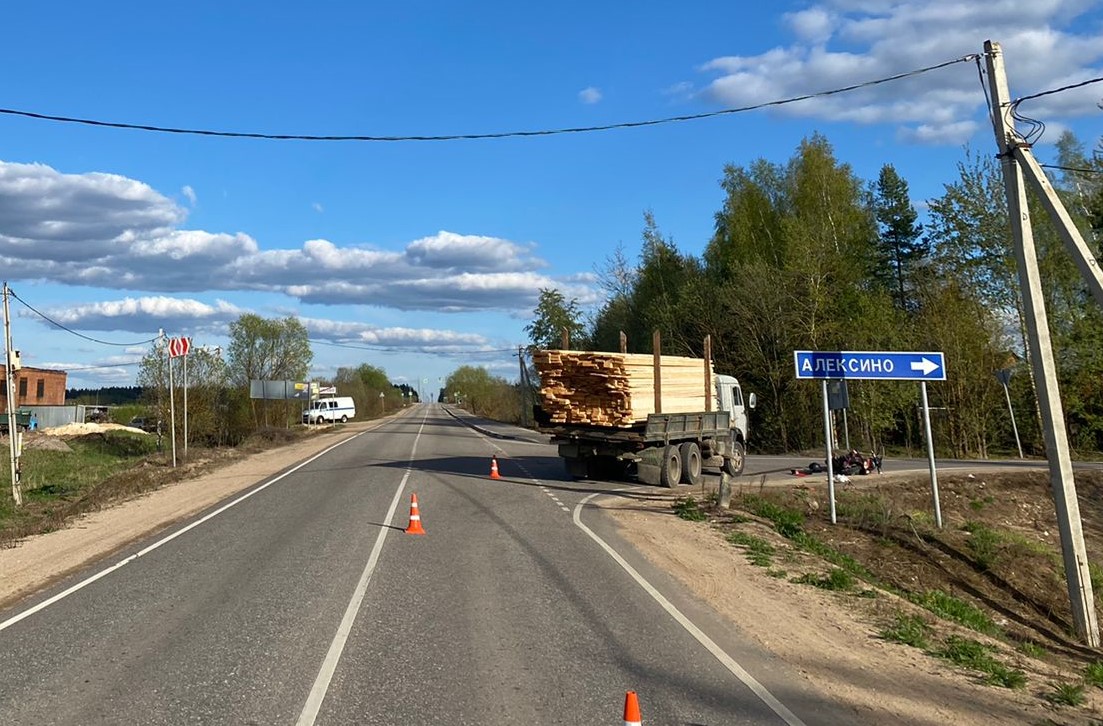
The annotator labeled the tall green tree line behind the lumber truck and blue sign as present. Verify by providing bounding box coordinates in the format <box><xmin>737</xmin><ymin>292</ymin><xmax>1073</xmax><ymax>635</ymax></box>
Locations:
<box><xmin>526</xmin><ymin>132</ymin><xmax>1103</xmax><ymax>458</ymax></box>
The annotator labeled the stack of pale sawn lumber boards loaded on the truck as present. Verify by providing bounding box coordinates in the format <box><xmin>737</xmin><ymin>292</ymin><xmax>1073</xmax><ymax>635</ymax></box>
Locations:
<box><xmin>533</xmin><ymin>351</ymin><xmax>715</xmax><ymax>427</ymax></box>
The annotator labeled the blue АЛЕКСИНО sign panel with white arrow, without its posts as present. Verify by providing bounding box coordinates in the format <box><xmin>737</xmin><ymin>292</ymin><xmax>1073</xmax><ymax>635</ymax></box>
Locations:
<box><xmin>793</xmin><ymin>351</ymin><xmax>946</xmax><ymax>381</ymax></box>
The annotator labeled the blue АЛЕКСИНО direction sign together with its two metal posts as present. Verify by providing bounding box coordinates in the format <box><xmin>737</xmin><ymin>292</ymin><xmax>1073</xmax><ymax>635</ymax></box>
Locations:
<box><xmin>793</xmin><ymin>351</ymin><xmax>946</xmax><ymax>530</ymax></box>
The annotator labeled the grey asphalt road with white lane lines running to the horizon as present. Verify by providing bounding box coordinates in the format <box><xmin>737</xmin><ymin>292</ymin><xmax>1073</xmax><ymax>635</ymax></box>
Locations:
<box><xmin>0</xmin><ymin>404</ymin><xmax>854</xmax><ymax>725</ymax></box>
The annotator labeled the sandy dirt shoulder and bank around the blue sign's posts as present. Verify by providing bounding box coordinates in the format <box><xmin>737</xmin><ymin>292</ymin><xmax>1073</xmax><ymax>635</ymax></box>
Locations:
<box><xmin>598</xmin><ymin>472</ymin><xmax>1103</xmax><ymax>726</ymax></box>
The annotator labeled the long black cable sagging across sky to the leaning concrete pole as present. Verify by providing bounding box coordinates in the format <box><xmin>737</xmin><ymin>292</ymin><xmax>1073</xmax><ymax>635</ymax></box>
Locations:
<box><xmin>0</xmin><ymin>54</ymin><xmax>981</xmax><ymax>141</ymax></box>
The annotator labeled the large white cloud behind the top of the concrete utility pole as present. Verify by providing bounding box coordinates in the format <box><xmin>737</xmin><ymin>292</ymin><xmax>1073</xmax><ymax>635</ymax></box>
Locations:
<box><xmin>698</xmin><ymin>0</ymin><xmax>1103</xmax><ymax>145</ymax></box>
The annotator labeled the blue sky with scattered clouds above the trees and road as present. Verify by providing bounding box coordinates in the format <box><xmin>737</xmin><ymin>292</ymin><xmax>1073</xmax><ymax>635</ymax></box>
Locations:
<box><xmin>0</xmin><ymin>0</ymin><xmax>1103</xmax><ymax>395</ymax></box>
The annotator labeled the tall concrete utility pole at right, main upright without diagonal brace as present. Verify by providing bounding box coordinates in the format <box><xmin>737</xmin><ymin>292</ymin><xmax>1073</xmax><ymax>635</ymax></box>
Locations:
<box><xmin>984</xmin><ymin>41</ymin><xmax>1103</xmax><ymax>648</ymax></box>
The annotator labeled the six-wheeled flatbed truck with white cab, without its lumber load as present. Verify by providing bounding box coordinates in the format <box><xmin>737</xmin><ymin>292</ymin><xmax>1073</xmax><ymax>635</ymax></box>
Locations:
<box><xmin>535</xmin><ymin>348</ymin><xmax>756</xmax><ymax>488</ymax></box>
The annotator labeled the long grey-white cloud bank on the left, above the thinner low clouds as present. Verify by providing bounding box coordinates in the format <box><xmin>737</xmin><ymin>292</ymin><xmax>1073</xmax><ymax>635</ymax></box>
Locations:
<box><xmin>0</xmin><ymin>161</ymin><xmax>592</xmax><ymax>314</ymax></box>
